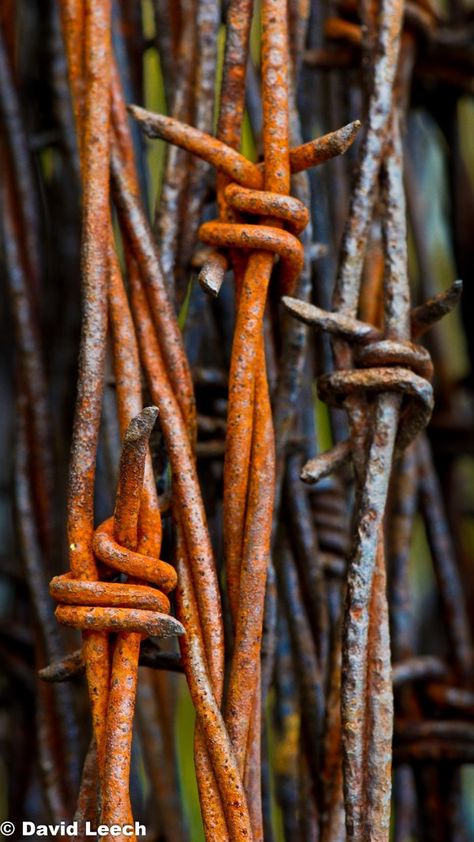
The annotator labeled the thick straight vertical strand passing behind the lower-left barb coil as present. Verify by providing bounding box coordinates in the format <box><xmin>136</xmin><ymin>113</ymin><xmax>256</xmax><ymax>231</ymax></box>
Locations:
<box><xmin>55</xmin><ymin>0</ymin><xmax>111</xmax><ymax>788</ymax></box>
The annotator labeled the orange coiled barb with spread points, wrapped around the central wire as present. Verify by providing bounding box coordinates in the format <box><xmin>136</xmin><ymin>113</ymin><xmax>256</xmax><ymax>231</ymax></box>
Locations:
<box><xmin>128</xmin><ymin>105</ymin><xmax>361</xmax><ymax>296</ymax></box>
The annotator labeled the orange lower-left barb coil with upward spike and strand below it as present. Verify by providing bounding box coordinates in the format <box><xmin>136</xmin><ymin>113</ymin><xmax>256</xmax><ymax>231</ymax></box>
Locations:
<box><xmin>50</xmin><ymin>407</ymin><xmax>184</xmax><ymax>825</ymax></box>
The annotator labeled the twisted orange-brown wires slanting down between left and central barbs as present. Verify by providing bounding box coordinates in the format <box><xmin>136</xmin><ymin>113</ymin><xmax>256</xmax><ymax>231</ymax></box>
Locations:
<box><xmin>112</xmin><ymin>59</ymin><xmax>250</xmax><ymax>839</ymax></box>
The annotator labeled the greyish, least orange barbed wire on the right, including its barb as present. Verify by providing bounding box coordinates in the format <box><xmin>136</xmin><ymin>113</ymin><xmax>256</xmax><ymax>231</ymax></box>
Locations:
<box><xmin>286</xmin><ymin>0</ymin><xmax>470</xmax><ymax>839</ymax></box>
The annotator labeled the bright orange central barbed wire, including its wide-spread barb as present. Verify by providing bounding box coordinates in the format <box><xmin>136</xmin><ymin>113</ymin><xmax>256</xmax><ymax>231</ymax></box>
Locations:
<box><xmin>130</xmin><ymin>0</ymin><xmax>359</xmax><ymax>838</ymax></box>
